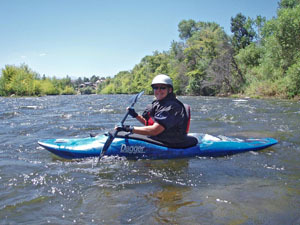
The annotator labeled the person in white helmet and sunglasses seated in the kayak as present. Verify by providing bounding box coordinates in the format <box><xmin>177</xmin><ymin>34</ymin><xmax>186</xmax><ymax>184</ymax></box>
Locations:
<box><xmin>115</xmin><ymin>74</ymin><xmax>189</xmax><ymax>145</ymax></box>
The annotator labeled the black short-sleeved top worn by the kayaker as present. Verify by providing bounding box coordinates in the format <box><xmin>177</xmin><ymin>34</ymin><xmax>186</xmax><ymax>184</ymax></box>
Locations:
<box><xmin>143</xmin><ymin>94</ymin><xmax>188</xmax><ymax>144</ymax></box>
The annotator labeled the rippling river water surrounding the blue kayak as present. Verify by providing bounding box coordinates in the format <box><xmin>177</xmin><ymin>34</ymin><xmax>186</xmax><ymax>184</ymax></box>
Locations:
<box><xmin>0</xmin><ymin>95</ymin><xmax>300</xmax><ymax>225</ymax></box>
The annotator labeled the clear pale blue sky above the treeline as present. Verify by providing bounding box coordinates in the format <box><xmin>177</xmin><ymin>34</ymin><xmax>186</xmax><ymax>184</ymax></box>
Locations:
<box><xmin>0</xmin><ymin>0</ymin><xmax>278</xmax><ymax>79</ymax></box>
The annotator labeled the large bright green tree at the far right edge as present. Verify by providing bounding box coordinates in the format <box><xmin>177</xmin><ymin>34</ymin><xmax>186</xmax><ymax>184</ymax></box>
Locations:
<box><xmin>240</xmin><ymin>0</ymin><xmax>300</xmax><ymax>98</ymax></box>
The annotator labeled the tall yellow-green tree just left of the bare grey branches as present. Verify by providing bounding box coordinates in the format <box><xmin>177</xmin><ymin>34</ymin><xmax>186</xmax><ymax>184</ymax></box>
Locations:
<box><xmin>184</xmin><ymin>22</ymin><xmax>228</xmax><ymax>95</ymax></box>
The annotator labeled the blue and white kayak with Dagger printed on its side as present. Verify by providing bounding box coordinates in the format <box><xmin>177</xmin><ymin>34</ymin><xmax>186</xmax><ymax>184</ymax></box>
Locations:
<box><xmin>38</xmin><ymin>133</ymin><xmax>278</xmax><ymax>159</ymax></box>
